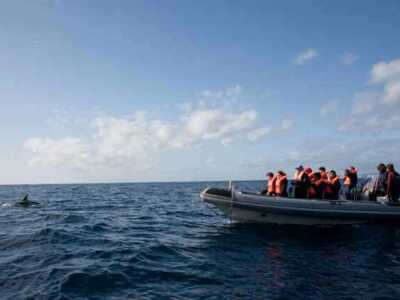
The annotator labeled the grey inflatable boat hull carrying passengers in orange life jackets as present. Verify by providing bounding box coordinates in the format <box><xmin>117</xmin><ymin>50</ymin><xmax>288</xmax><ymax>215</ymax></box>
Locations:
<box><xmin>200</xmin><ymin>187</ymin><xmax>400</xmax><ymax>225</ymax></box>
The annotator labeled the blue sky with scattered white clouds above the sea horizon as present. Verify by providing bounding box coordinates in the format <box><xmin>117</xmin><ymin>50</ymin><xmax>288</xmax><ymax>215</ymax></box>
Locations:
<box><xmin>0</xmin><ymin>0</ymin><xmax>400</xmax><ymax>183</ymax></box>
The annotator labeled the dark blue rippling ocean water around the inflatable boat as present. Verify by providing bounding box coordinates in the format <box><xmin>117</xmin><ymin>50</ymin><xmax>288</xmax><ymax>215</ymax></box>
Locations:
<box><xmin>0</xmin><ymin>181</ymin><xmax>400</xmax><ymax>300</ymax></box>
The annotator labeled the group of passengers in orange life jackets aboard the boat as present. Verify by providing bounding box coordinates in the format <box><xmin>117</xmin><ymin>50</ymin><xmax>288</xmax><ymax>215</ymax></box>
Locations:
<box><xmin>262</xmin><ymin>164</ymin><xmax>400</xmax><ymax>202</ymax></box>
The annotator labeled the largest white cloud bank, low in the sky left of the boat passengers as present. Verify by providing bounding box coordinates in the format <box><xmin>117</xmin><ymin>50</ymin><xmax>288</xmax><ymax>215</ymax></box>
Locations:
<box><xmin>25</xmin><ymin>87</ymin><xmax>293</xmax><ymax>170</ymax></box>
